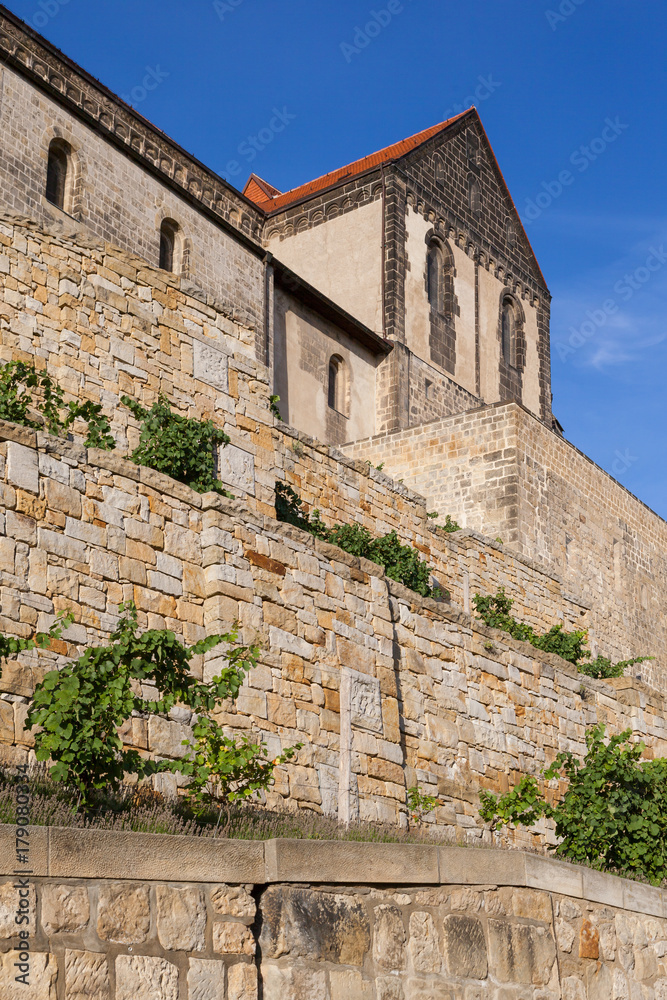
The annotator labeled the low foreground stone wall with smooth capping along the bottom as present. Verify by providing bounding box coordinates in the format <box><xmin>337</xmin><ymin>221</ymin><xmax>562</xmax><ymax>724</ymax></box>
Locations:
<box><xmin>0</xmin><ymin>826</ymin><xmax>667</xmax><ymax>1000</ymax></box>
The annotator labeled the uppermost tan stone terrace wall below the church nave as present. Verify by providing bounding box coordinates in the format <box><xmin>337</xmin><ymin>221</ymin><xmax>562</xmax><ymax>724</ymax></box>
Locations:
<box><xmin>0</xmin><ymin>217</ymin><xmax>275</xmax><ymax>511</ymax></box>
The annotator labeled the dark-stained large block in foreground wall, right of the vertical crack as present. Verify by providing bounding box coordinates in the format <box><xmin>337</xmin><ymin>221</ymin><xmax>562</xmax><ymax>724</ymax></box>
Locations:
<box><xmin>260</xmin><ymin>886</ymin><xmax>371</xmax><ymax>965</ymax></box>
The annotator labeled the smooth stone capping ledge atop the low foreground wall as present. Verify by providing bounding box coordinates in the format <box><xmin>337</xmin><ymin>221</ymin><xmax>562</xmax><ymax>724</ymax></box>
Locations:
<box><xmin>0</xmin><ymin>824</ymin><xmax>667</xmax><ymax>918</ymax></box>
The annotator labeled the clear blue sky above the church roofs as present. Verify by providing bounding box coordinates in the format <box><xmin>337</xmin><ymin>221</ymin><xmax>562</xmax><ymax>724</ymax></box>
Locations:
<box><xmin>8</xmin><ymin>0</ymin><xmax>667</xmax><ymax>517</ymax></box>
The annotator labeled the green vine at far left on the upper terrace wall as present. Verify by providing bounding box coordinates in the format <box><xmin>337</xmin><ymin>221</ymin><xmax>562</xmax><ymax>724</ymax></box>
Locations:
<box><xmin>0</xmin><ymin>361</ymin><xmax>116</xmax><ymax>451</ymax></box>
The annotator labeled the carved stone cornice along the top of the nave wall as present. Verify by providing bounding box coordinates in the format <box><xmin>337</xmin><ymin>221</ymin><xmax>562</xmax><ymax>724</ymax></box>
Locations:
<box><xmin>0</xmin><ymin>5</ymin><xmax>264</xmax><ymax>256</ymax></box>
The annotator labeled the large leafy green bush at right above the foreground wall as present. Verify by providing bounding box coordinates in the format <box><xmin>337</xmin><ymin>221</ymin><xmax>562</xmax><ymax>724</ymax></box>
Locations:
<box><xmin>480</xmin><ymin>725</ymin><xmax>667</xmax><ymax>885</ymax></box>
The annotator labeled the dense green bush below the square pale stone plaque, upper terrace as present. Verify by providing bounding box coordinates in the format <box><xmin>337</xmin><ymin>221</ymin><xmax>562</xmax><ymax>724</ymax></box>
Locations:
<box><xmin>120</xmin><ymin>395</ymin><xmax>231</xmax><ymax>497</ymax></box>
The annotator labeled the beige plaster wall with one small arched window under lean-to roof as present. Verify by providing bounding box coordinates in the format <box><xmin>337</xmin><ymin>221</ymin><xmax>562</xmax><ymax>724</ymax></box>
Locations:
<box><xmin>274</xmin><ymin>291</ymin><xmax>377</xmax><ymax>444</ymax></box>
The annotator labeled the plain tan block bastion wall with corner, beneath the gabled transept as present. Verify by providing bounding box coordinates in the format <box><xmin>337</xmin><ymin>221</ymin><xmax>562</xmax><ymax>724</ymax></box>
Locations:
<box><xmin>344</xmin><ymin>403</ymin><xmax>667</xmax><ymax>689</ymax></box>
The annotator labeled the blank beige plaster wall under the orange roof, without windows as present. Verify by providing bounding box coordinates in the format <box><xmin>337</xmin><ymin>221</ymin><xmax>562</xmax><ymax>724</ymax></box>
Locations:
<box><xmin>267</xmin><ymin>198</ymin><xmax>382</xmax><ymax>334</ymax></box>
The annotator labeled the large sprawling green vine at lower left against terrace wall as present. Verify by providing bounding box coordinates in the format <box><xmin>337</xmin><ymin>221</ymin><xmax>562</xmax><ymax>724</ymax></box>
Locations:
<box><xmin>22</xmin><ymin>603</ymin><xmax>259</xmax><ymax>803</ymax></box>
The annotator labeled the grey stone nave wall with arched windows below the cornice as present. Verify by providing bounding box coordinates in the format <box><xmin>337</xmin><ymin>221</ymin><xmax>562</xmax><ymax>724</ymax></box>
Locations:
<box><xmin>0</xmin><ymin>67</ymin><xmax>264</xmax><ymax>340</ymax></box>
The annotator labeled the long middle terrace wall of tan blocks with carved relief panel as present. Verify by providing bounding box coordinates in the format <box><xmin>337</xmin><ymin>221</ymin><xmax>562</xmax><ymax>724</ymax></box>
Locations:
<box><xmin>0</xmin><ymin>425</ymin><xmax>667</xmax><ymax>849</ymax></box>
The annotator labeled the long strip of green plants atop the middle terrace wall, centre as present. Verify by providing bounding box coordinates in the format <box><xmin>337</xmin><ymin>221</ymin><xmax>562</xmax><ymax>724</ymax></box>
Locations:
<box><xmin>275</xmin><ymin>482</ymin><xmax>446</xmax><ymax>598</ymax></box>
